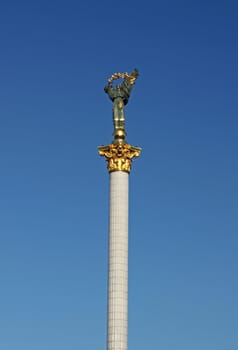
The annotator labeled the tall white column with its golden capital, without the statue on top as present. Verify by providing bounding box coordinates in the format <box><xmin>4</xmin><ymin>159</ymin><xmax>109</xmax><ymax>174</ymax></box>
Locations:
<box><xmin>99</xmin><ymin>141</ymin><xmax>141</xmax><ymax>350</ymax></box>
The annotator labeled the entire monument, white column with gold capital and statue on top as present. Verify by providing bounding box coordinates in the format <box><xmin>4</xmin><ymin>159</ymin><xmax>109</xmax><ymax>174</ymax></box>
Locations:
<box><xmin>98</xmin><ymin>69</ymin><xmax>141</xmax><ymax>350</ymax></box>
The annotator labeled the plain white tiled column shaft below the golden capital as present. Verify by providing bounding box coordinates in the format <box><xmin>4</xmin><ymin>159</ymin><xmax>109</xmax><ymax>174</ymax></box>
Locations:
<box><xmin>107</xmin><ymin>171</ymin><xmax>129</xmax><ymax>350</ymax></box>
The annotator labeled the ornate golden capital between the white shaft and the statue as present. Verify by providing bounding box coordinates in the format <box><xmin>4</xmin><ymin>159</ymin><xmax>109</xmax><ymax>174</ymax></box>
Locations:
<box><xmin>98</xmin><ymin>142</ymin><xmax>141</xmax><ymax>173</ymax></box>
